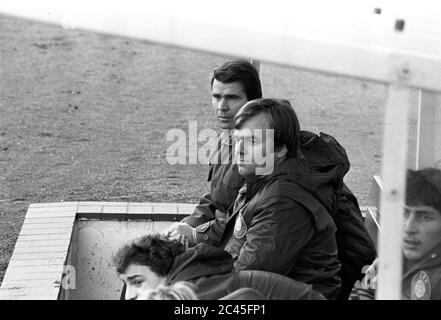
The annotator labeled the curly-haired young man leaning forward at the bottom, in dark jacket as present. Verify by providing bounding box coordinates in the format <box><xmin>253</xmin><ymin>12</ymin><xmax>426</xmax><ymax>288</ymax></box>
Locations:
<box><xmin>113</xmin><ymin>234</ymin><xmax>324</xmax><ymax>300</ymax></box>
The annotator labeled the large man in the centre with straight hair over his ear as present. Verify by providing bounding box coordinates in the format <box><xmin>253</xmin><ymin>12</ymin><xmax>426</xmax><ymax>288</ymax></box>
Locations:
<box><xmin>217</xmin><ymin>99</ymin><xmax>340</xmax><ymax>298</ymax></box>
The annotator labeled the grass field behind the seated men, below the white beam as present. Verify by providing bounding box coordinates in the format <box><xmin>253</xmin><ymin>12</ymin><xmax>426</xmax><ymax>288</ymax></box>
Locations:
<box><xmin>0</xmin><ymin>16</ymin><xmax>420</xmax><ymax>282</ymax></box>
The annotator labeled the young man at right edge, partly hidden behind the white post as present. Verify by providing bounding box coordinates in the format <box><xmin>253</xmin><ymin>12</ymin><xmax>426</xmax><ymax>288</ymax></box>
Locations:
<box><xmin>351</xmin><ymin>168</ymin><xmax>441</xmax><ymax>300</ymax></box>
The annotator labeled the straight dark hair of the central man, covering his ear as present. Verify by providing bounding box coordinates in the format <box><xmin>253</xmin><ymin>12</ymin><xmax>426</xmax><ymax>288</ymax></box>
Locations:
<box><xmin>233</xmin><ymin>99</ymin><xmax>300</xmax><ymax>158</ymax></box>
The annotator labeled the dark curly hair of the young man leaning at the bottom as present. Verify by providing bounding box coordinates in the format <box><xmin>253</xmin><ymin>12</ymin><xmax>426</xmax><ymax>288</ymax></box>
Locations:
<box><xmin>112</xmin><ymin>234</ymin><xmax>185</xmax><ymax>276</ymax></box>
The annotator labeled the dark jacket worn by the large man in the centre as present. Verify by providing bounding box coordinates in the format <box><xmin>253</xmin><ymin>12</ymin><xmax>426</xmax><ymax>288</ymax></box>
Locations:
<box><xmin>221</xmin><ymin>158</ymin><xmax>340</xmax><ymax>298</ymax></box>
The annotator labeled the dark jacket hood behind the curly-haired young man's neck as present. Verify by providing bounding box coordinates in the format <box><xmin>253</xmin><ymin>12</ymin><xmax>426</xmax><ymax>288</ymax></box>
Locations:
<box><xmin>167</xmin><ymin>243</ymin><xmax>233</xmax><ymax>283</ymax></box>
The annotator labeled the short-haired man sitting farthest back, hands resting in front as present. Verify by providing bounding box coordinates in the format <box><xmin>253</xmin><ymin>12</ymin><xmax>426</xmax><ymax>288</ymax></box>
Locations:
<box><xmin>164</xmin><ymin>59</ymin><xmax>254</xmax><ymax>245</ymax></box>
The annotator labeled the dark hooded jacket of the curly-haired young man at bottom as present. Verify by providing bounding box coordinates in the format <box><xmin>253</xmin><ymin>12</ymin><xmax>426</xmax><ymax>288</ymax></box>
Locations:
<box><xmin>167</xmin><ymin>243</ymin><xmax>324</xmax><ymax>300</ymax></box>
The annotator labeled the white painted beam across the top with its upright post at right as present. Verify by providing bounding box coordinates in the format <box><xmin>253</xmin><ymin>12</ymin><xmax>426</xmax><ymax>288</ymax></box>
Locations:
<box><xmin>0</xmin><ymin>0</ymin><xmax>441</xmax><ymax>299</ymax></box>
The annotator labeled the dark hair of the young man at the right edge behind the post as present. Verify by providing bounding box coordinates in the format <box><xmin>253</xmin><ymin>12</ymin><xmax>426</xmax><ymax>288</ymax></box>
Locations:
<box><xmin>406</xmin><ymin>168</ymin><xmax>441</xmax><ymax>213</ymax></box>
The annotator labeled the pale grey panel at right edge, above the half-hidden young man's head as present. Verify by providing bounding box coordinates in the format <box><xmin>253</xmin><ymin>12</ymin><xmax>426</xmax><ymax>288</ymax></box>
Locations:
<box><xmin>416</xmin><ymin>90</ymin><xmax>441</xmax><ymax>169</ymax></box>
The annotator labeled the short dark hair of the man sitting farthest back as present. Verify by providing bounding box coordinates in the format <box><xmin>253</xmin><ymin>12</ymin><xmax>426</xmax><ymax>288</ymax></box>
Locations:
<box><xmin>211</xmin><ymin>59</ymin><xmax>262</xmax><ymax>100</ymax></box>
